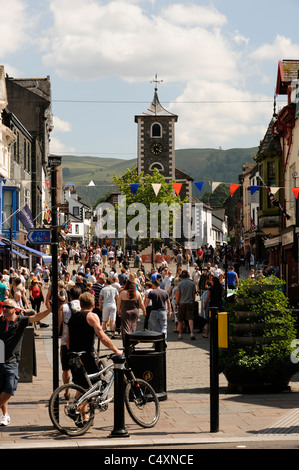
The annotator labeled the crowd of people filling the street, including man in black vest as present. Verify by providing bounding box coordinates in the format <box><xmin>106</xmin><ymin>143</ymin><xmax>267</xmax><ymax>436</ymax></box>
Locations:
<box><xmin>0</xmin><ymin>242</ymin><xmax>282</xmax><ymax>425</ymax></box>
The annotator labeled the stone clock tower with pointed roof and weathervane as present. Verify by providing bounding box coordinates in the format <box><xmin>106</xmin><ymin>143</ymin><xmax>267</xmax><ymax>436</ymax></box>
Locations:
<box><xmin>135</xmin><ymin>77</ymin><xmax>178</xmax><ymax>181</ymax></box>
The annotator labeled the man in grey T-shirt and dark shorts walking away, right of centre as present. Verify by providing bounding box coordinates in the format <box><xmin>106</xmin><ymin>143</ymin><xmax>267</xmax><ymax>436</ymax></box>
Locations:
<box><xmin>175</xmin><ymin>270</ymin><xmax>196</xmax><ymax>340</ymax></box>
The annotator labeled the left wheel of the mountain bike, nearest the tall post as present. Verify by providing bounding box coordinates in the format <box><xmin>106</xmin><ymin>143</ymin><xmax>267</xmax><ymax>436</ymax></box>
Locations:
<box><xmin>49</xmin><ymin>384</ymin><xmax>94</xmax><ymax>436</ymax></box>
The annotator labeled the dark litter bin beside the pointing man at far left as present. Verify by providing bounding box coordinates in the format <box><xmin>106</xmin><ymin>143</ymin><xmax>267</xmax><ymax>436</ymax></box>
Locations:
<box><xmin>19</xmin><ymin>326</ymin><xmax>36</xmax><ymax>383</ymax></box>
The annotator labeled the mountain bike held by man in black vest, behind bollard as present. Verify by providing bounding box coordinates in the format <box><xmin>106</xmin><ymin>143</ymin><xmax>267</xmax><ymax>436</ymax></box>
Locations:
<box><xmin>49</xmin><ymin>346</ymin><xmax>160</xmax><ymax>436</ymax></box>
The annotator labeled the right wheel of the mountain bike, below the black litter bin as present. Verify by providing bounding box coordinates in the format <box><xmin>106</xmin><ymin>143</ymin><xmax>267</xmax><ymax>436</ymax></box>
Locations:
<box><xmin>125</xmin><ymin>379</ymin><xmax>160</xmax><ymax>428</ymax></box>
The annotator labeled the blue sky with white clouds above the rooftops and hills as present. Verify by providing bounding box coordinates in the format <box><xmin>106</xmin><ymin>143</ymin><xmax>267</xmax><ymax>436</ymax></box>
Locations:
<box><xmin>0</xmin><ymin>0</ymin><xmax>299</xmax><ymax>159</ymax></box>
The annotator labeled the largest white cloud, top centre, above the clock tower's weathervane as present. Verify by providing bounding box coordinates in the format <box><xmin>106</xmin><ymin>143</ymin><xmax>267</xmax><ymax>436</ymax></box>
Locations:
<box><xmin>43</xmin><ymin>0</ymin><xmax>238</xmax><ymax>82</ymax></box>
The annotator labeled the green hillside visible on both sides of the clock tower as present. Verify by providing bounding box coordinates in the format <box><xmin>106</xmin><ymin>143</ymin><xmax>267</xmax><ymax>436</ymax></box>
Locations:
<box><xmin>62</xmin><ymin>147</ymin><xmax>258</xmax><ymax>205</ymax></box>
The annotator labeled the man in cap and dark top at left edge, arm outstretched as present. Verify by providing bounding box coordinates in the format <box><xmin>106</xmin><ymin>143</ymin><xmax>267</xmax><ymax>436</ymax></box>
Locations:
<box><xmin>0</xmin><ymin>299</ymin><xmax>52</xmax><ymax>426</ymax></box>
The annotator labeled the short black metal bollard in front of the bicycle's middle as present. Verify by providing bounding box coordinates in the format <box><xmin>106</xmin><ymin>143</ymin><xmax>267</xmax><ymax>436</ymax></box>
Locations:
<box><xmin>110</xmin><ymin>355</ymin><xmax>130</xmax><ymax>437</ymax></box>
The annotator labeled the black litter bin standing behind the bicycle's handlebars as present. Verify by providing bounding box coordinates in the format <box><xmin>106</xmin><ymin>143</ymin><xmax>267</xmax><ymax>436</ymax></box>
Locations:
<box><xmin>125</xmin><ymin>330</ymin><xmax>167</xmax><ymax>401</ymax></box>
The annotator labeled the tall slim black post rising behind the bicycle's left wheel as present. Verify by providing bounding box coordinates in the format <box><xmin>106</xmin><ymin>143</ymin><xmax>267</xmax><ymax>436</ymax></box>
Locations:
<box><xmin>48</xmin><ymin>155</ymin><xmax>61</xmax><ymax>390</ymax></box>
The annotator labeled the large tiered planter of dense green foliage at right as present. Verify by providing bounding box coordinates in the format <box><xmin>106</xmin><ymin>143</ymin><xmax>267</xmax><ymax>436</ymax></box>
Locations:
<box><xmin>220</xmin><ymin>280</ymin><xmax>298</xmax><ymax>392</ymax></box>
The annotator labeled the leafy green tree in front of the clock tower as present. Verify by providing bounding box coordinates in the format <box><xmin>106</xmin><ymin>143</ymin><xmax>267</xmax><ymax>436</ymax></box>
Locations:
<box><xmin>113</xmin><ymin>166</ymin><xmax>187</xmax><ymax>262</ymax></box>
